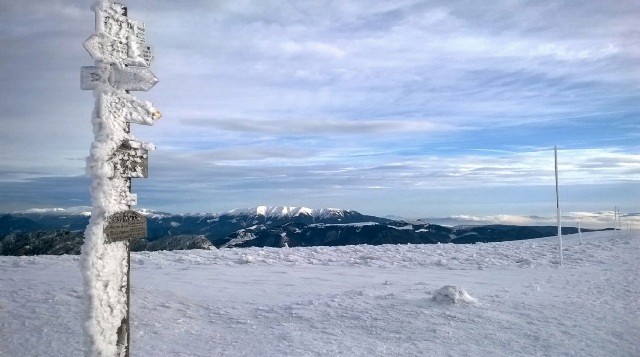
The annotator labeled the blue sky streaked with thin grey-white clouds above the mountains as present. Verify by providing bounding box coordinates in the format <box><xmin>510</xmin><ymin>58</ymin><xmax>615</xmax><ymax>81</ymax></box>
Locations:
<box><xmin>0</xmin><ymin>0</ymin><xmax>640</xmax><ymax>225</ymax></box>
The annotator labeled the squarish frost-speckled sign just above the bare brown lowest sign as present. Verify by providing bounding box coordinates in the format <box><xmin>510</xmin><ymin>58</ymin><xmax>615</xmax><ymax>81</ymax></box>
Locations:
<box><xmin>111</xmin><ymin>140</ymin><xmax>149</xmax><ymax>178</ymax></box>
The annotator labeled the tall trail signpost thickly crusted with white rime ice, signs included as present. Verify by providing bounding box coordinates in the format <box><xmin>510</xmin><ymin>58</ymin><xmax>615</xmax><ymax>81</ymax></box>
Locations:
<box><xmin>80</xmin><ymin>0</ymin><xmax>161</xmax><ymax>356</ymax></box>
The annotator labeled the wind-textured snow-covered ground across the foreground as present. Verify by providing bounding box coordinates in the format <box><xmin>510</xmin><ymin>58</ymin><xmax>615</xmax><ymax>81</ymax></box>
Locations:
<box><xmin>0</xmin><ymin>231</ymin><xmax>640</xmax><ymax>356</ymax></box>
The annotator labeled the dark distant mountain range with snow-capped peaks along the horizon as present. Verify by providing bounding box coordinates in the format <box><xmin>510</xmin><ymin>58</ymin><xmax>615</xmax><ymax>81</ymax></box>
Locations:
<box><xmin>0</xmin><ymin>206</ymin><xmax>608</xmax><ymax>255</ymax></box>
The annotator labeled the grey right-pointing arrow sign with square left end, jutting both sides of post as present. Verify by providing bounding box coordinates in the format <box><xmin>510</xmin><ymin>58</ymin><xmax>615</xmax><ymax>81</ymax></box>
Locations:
<box><xmin>80</xmin><ymin>66</ymin><xmax>158</xmax><ymax>92</ymax></box>
